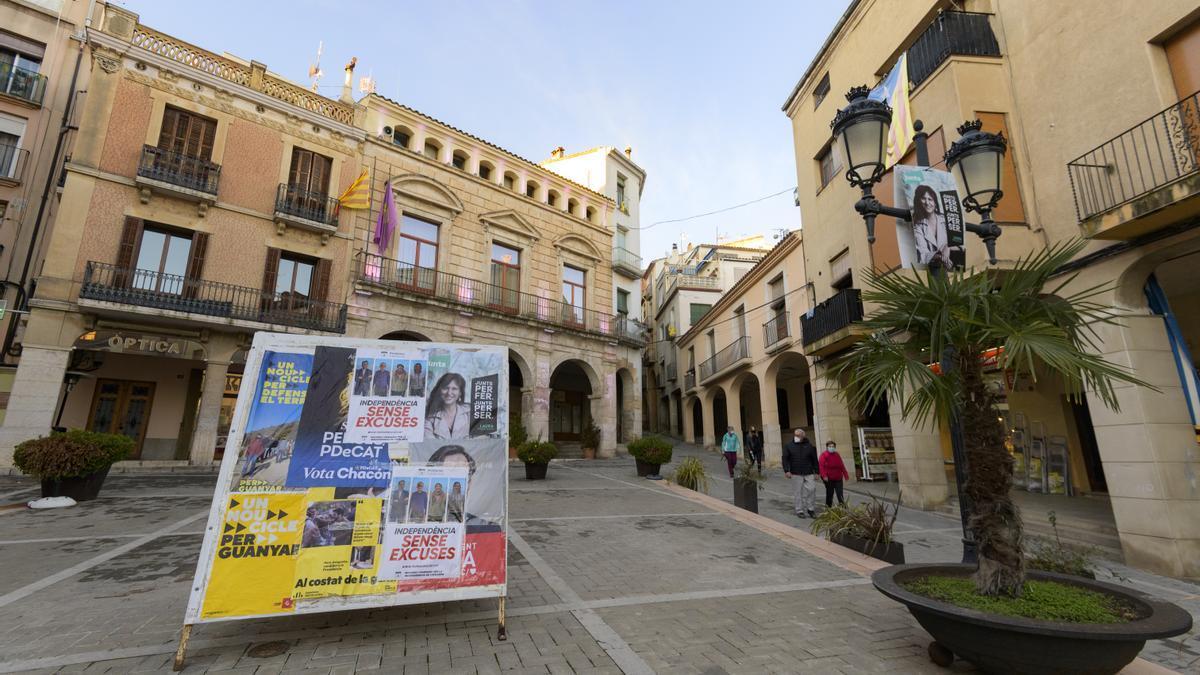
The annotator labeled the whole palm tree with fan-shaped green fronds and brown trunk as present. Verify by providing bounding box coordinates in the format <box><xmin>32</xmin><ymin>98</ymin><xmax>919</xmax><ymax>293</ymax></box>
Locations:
<box><xmin>834</xmin><ymin>240</ymin><xmax>1145</xmax><ymax>597</ymax></box>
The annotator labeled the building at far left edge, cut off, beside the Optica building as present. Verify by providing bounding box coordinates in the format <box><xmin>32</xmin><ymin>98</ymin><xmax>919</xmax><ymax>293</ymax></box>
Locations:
<box><xmin>0</xmin><ymin>0</ymin><xmax>99</xmax><ymax>422</ymax></box>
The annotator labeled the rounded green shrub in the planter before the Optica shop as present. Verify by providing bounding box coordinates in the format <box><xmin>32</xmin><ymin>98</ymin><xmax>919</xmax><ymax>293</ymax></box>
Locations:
<box><xmin>12</xmin><ymin>429</ymin><xmax>133</xmax><ymax>480</ymax></box>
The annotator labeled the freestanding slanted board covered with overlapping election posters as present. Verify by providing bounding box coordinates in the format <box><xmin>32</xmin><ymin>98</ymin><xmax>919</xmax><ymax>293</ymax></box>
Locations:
<box><xmin>185</xmin><ymin>333</ymin><xmax>509</xmax><ymax>623</ymax></box>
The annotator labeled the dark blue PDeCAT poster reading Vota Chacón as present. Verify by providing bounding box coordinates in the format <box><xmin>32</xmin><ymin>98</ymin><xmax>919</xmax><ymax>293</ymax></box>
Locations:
<box><xmin>287</xmin><ymin>347</ymin><xmax>391</xmax><ymax>489</ymax></box>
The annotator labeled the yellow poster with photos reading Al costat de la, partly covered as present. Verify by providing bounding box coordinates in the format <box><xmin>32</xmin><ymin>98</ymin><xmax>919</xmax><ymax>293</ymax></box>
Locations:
<box><xmin>292</xmin><ymin>488</ymin><xmax>396</xmax><ymax>599</ymax></box>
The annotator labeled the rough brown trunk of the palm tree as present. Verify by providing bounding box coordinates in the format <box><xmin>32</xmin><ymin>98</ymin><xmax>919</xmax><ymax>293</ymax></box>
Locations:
<box><xmin>956</xmin><ymin>350</ymin><xmax>1025</xmax><ymax>597</ymax></box>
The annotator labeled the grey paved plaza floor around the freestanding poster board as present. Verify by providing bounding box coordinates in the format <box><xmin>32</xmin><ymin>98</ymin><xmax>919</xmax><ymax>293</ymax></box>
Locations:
<box><xmin>0</xmin><ymin>448</ymin><xmax>1176</xmax><ymax>675</ymax></box>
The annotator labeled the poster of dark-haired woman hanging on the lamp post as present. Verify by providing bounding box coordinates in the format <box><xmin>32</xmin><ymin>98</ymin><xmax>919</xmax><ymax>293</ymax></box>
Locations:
<box><xmin>894</xmin><ymin>165</ymin><xmax>966</xmax><ymax>270</ymax></box>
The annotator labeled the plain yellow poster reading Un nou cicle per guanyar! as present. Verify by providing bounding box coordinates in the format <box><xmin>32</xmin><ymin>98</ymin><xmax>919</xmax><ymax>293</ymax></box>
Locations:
<box><xmin>200</xmin><ymin>492</ymin><xmax>305</xmax><ymax>619</ymax></box>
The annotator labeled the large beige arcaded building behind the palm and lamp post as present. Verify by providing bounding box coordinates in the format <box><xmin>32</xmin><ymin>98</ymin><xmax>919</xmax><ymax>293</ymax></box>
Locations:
<box><xmin>784</xmin><ymin>0</ymin><xmax>1200</xmax><ymax>577</ymax></box>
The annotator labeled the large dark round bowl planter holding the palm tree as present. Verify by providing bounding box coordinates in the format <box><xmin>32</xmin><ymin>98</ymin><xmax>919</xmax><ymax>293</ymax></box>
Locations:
<box><xmin>871</xmin><ymin>563</ymin><xmax>1192</xmax><ymax>675</ymax></box>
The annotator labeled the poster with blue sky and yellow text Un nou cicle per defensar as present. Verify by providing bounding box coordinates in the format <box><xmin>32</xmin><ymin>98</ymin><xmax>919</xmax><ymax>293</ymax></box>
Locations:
<box><xmin>235</xmin><ymin>352</ymin><xmax>312</xmax><ymax>492</ymax></box>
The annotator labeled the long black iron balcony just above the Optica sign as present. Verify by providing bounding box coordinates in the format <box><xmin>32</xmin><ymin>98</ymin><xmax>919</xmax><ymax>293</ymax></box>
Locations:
<box><xmin>79</xmin><ymin>261</ymin><xmax>346</xmax><ymax>333</ymax></box>
